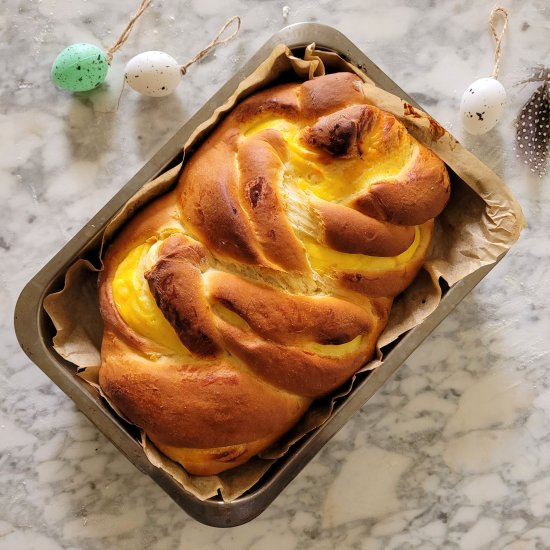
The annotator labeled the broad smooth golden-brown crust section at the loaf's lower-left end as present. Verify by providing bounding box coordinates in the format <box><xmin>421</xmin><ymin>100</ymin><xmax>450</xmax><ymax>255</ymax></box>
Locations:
<box><xmin>100</xmin><ymin>330</ymin><xmax>310</xmax><ymax>449</ymax></box>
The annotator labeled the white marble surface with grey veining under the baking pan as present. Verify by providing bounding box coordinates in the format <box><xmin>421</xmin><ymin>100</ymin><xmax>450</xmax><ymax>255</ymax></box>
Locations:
<box><xmin>0</xmin><ymin>0</ymin><xmax>550</xmax><ymax>550</ymax></box>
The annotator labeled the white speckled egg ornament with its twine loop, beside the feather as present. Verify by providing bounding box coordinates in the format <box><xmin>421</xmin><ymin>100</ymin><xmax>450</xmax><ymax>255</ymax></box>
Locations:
<box><xmin>460</xmin><ymin>8</ymin><xmax>508</xmax><ymax>135</ymax></box>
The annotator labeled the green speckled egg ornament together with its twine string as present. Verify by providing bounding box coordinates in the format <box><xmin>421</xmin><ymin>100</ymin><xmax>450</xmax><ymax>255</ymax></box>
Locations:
<box><xmin>51</xmin><ymin>0</ymin><xmax>151</xmax><ymax>92</ymax></box>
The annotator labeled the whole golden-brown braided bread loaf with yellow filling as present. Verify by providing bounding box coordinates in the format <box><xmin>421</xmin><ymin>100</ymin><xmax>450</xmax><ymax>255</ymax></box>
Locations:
<box><xmin>100</xmin><ymin>73</ymin><xmax>450</xmax><ymax>475</ymax></box>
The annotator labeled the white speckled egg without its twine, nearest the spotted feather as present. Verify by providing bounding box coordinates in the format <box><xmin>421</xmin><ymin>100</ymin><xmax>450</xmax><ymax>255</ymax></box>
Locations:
<box><xmin>460</xmin><ymin>77</ymin><xmax>506</xmax><ymax>135</ymax></box>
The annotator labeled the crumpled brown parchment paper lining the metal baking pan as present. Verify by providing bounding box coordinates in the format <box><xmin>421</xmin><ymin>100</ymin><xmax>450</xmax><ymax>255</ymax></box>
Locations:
<box><xmin>44</xmin><ymin>44</ymin><xmax>525</xmax><ymax>501</ymax></box>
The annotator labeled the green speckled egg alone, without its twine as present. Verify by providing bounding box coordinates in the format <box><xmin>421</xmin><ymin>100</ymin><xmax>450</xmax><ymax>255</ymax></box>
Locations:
<box><xmin>52</xmin><ymin>44</ymin><xmax>109</xmax><ymax>92</ymax></box>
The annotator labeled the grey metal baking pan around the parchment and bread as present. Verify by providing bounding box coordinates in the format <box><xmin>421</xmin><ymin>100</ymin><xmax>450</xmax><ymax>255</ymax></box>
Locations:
<box><xmin>15</xmin><ymin>23</ymin><xmax>504</xmax><ymax>527</ymax></box>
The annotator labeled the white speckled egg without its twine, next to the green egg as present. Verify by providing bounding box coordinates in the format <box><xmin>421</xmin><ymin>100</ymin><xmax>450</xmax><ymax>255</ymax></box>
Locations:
<box><xmin>124</xmin><ymin>51</ymin><xmax>181</xmax><ymax>97</ymax></box>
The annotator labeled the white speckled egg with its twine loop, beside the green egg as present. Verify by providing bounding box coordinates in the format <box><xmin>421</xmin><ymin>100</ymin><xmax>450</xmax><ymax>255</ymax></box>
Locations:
<box><xmin>124</xmin><ymin>16</ymin><xmax>241</xmax><ymax>97</ymax></box>
